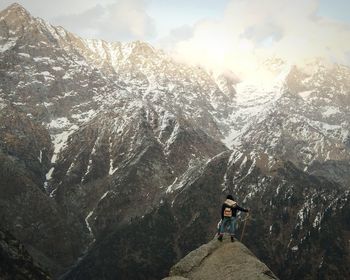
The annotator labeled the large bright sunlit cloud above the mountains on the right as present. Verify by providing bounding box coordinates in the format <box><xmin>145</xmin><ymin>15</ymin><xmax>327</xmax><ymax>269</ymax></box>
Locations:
<box><xmin>169</xmin><ymin>0</ymin><xmax>350</xmax><ymax>76</ymax></box>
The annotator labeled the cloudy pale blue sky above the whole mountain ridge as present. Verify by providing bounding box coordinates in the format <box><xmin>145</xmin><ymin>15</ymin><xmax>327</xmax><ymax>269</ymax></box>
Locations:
<box><xmin>0</xmin><ymin>0</ymin><xmax>350</xmax><ymax>75</ymax></box>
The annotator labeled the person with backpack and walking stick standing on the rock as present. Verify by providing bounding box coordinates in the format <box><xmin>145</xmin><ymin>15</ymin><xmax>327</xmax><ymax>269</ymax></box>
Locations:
<box><xmin>218</xmin><ymin>194</ymin><xmax>249</xmax><ymax>242</ymax></box>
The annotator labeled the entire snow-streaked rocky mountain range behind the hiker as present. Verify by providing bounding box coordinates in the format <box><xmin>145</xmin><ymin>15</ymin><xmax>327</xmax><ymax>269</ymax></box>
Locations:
<box><xmin>0</xmin><ymin>4</ymin><xmax>350</xmax><ymax>279</ymax></box>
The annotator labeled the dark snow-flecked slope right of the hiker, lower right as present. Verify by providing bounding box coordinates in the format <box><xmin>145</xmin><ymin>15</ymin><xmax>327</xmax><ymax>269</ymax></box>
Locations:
<box><xmin>223</xmin><ymin>154</ymin><xmax>349</xmax><ymax>279</ymax></box>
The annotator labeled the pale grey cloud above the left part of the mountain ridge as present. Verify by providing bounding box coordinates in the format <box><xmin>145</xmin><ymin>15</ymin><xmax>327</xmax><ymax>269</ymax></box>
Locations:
<box><xmin>54</xmin><ymin>0</ymin><xmax>156</xmax><ymax>41</ymax></box>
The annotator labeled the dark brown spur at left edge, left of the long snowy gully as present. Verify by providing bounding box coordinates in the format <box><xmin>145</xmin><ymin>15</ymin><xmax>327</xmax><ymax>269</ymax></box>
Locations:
<box><xmin>0</xmin><ymin>106</ymin><xmax>89</xmax><ymax>273</ymax></box>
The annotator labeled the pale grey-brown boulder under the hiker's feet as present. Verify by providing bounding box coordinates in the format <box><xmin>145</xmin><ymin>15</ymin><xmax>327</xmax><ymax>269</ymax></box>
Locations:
<box><xmin>163</xmin><ymin>239</ymin><xmax>278</xmax><ymax>280</ymax></box>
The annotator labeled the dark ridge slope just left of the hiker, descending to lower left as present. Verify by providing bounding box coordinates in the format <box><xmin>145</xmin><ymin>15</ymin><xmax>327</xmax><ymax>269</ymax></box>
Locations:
<box><xmin>64</xmin><ymin>155</ymin><xmax>230</xmax><ymax>279</ymax></box>
